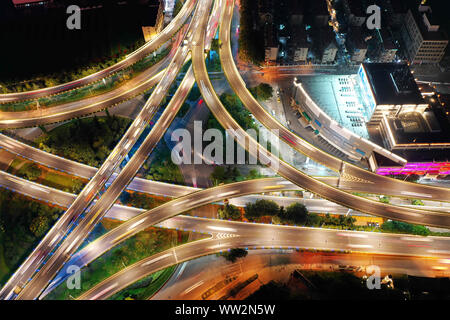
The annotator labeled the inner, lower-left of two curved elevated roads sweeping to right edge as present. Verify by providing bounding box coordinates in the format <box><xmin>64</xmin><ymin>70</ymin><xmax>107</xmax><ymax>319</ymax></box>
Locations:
<box><xmin>192</xmin><ymin>1</ymin><xmax>450</xmax><ymax>228</ymax></box>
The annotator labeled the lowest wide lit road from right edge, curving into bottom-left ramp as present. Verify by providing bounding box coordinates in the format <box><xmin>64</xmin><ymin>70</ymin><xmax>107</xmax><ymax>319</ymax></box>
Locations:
<box><xmin>78</xmin><ymin>225</ymin><xmax>450</xmax><ymax>300</ymax></box>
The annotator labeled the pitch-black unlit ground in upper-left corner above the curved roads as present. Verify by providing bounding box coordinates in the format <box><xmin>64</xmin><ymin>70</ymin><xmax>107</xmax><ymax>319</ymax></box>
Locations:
<box><xmin>0</xmin><ymin>0</ymin><xmax>155</xmax><ymax>82</ymax></box>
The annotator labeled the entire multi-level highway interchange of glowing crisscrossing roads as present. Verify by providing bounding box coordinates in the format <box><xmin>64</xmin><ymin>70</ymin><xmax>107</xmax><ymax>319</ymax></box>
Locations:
<box><xmin>0</xmin><ymin>0</ymin><xmax>450</xmax><ymax>300</ymax></box>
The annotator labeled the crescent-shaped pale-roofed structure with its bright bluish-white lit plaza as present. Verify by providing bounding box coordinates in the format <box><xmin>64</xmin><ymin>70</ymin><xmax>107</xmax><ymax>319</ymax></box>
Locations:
<box><xmin>291</xmin><ymin>75</ymin><xmax>406</xmax><ymax>165</ymax></box>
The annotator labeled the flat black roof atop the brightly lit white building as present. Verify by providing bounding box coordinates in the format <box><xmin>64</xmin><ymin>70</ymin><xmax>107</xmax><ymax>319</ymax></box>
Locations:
<box><xmin>362</xmin><ymin>63</ymin><xmax>424</xmax><ymax>105</ymax></box>
